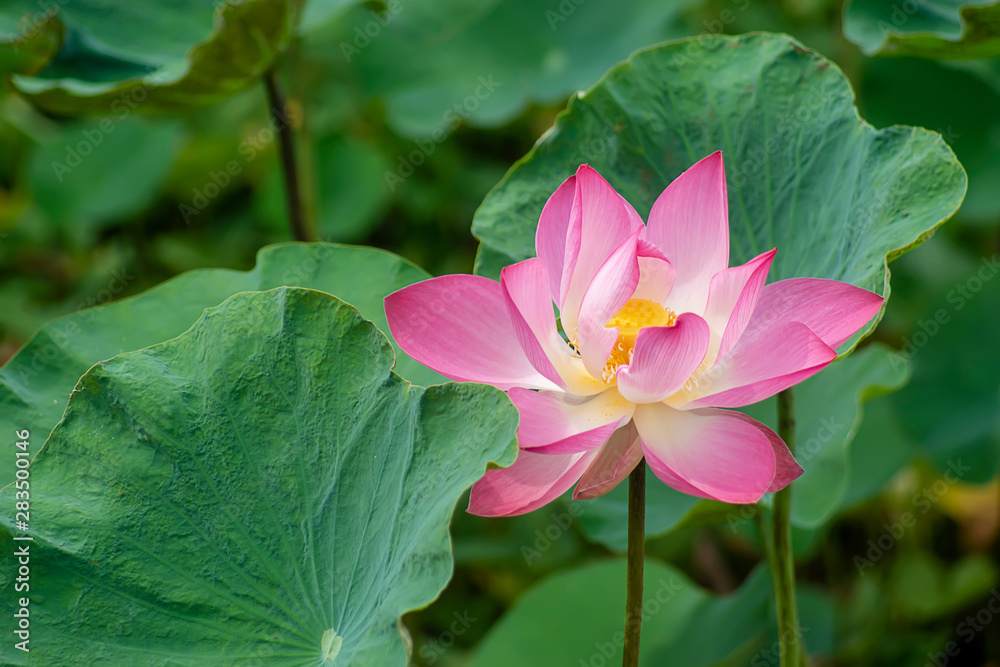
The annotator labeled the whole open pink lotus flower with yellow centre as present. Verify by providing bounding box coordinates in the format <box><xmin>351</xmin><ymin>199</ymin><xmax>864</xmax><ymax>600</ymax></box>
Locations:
<box><xmin>385</xmin><ymin>153</ymin><xmax>883</xmax><ymax>516</ymax></box>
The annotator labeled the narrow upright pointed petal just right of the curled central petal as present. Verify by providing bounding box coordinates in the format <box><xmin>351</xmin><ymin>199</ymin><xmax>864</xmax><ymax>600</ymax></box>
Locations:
<box><xmin>705</xmin><ymin>250</ymin><xmax>777</xmax><ymax>363</ymax></box>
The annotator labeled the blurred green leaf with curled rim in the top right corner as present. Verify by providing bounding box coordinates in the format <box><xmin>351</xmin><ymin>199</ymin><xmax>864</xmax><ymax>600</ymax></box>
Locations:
<box><xmin>844</xmin><ymin>0</ymin><xmax>1000</xmax><ymax>60</ymax></box>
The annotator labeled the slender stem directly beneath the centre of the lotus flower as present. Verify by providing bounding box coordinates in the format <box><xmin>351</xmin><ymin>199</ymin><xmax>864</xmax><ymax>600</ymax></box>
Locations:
<box><xmin>622</xmin><ymin>460</ymin><xmax>646</xmax><ymax>667</ymax></box>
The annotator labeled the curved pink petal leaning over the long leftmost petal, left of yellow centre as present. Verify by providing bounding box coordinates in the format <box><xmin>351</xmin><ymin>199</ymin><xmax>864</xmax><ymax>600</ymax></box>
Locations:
<box><xmin>500</xmin><ymin>258</ymin><xmax>606</xmax><ymax>395</ymax></box>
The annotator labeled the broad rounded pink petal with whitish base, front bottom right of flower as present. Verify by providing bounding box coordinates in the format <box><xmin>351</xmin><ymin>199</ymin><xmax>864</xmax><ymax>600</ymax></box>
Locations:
<box><xmin>634</xmin><ymin>403</ymin><xmax>775</xmax><ymax>504</ymax></box>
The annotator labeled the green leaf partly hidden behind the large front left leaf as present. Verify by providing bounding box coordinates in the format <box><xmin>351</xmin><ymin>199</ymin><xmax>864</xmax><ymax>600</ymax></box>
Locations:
<box><xmin>0</xmin><ymin>244</ymin><xmax>442</xmax><ymax>484</ymax></box>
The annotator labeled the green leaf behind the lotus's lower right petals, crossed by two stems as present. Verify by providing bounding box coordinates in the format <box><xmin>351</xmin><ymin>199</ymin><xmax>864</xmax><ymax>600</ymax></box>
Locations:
<box><xmin>571</xmin><ymin>345</ymin><xmax>909</xmax><ymax>551</ymax></box>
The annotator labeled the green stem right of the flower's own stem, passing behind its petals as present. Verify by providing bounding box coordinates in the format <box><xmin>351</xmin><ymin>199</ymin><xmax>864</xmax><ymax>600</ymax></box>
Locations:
<box><xmin>771</xmin><ymin>389</ymin><xmax>805</xmax><ymax>667</ymax></box>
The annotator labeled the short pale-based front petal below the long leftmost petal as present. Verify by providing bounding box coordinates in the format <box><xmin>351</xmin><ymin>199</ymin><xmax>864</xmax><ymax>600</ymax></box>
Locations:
<box><xmin>507</xmin><ymin>388</ymin><xmax>635</xmax><ymax>453</ymax></box>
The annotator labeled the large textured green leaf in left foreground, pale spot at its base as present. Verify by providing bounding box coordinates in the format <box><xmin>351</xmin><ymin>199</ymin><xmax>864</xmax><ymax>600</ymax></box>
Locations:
<box><xmin>0</xmin><ymin>288</ymin><xmax>517</xmax><ymax>667</ymax></box>
